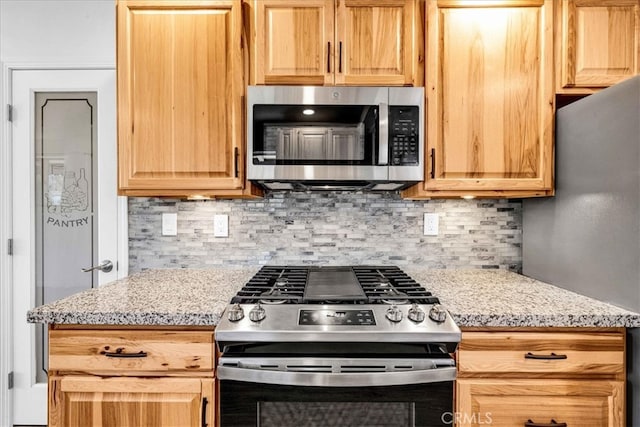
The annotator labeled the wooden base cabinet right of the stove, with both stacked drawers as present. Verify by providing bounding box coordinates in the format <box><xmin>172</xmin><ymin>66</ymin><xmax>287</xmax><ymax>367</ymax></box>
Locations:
<box><xmin>456</xmin><ymin>328</ymin><xmax>625</xmax><ymax>427</ymax></box>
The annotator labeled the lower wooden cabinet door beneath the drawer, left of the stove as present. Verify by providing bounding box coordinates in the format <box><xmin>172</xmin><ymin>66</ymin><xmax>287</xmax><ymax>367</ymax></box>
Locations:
<box><xmin>49</xmin><ymin>376</ymin><xmax>215</xmax><ymax>427</ymax></box>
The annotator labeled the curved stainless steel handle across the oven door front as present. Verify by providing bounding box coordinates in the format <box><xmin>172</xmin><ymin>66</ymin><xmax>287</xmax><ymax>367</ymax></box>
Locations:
<box><xmin>217</xmin><ymin>366</ymin><xmax>456</xmax><ymax>387</ymax></box>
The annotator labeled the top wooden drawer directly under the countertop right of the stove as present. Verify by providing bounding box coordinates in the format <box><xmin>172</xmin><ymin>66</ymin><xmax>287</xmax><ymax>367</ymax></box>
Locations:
<box><xmin>458</xmin><ymin>332</ymin><xmax>625</xmax><ymax>377</ymax></box>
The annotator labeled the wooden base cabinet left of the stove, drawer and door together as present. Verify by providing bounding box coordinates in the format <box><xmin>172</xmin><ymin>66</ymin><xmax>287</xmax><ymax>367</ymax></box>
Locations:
<box><xmin>48</xmin><ymin>326</ymin><xmax>215</xmax><ymax>427</ymax></box>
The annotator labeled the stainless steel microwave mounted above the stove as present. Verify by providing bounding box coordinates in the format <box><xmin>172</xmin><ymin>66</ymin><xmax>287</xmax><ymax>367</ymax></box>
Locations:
<box><xmin>247</xmin><ymin>86</ymin><xmax>425</xmax><ymax>190</ymax></box>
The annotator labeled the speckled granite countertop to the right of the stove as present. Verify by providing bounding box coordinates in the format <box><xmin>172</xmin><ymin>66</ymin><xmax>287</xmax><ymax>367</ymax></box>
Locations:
<box><xmin>406</xmin><ymin>269</ymin><xmax>640</xmax><ymax>328</ymax></box>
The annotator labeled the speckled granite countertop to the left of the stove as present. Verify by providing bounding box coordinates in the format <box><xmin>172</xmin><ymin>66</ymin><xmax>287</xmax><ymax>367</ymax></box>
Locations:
<box><xmin>27</xmin><ymin>267</ymin><xmax>259</xmax><ymax>326</ymax></box>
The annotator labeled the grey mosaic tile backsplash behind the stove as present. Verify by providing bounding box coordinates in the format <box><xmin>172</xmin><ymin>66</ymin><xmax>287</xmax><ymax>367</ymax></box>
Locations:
<box><xmin>129</xmin><ymin>192</ymin><xmax>522</xmax><ymax>272</ymax></box>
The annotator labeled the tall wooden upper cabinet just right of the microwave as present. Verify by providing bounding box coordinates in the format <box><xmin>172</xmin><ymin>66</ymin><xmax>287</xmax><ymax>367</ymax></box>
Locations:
<box><xmin>403</xmin><ymin>0</ymin><xmax>554</xmax><ymax>198</ymax></box>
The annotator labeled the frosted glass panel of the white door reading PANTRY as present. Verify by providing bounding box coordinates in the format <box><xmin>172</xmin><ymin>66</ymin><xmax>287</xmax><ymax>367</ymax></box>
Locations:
<box><xmin>34</xmin><ymin>92</ymin><xmax>97</xmax><ymax>381</ymax></box>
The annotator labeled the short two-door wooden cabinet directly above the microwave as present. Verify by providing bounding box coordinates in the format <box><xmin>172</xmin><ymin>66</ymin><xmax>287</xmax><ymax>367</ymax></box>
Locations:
<box><xmin>247</xmin><ymin>0</ymin><xmax>424</xmax><ymax>86</ymax></box>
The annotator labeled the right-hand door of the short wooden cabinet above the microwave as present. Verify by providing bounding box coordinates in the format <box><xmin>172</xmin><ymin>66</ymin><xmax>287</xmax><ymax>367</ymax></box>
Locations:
<box><xmin>335</xmin><ymin>0</ymin><xmax>420</xmax><ymax>86</ymax></box>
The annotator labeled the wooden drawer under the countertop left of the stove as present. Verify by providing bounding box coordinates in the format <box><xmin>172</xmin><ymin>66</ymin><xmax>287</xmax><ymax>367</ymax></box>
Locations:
<box><xmin>49</xmin><ymin>330</ymin><xmax>214</xmax><ymax>375</ymax></box>
